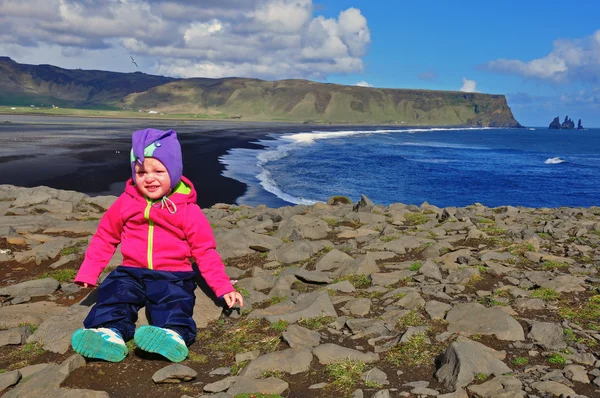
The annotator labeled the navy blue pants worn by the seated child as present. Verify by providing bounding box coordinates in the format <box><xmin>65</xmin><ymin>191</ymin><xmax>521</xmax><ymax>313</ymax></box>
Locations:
<box><xmin>83</xmin><ymin>266</ymin><xmax>197</xmax><ymax>345</ymax></box>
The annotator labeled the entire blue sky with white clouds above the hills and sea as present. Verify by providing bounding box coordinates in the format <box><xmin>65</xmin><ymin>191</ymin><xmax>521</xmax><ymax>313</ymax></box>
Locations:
<box><xmin>0</xmin><ymin>0</ymin><xmax>600</xmax><ymax>127</ymax></box>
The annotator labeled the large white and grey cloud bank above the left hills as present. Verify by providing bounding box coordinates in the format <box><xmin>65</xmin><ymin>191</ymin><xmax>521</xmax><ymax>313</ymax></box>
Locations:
<box><xmin>0</xmin><ymin>0</ymin><xmax>371</xmax><ymax>79</ymax></box>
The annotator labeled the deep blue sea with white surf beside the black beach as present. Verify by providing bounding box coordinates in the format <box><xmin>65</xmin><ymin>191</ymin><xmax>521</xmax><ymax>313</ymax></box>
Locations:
<box><xmin>220</xmin><ymin>127</ymin><xmax>600</xmax><ymax>207</ymax></box>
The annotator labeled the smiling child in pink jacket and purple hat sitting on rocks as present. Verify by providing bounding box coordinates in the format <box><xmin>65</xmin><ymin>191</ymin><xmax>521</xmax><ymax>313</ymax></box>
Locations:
<box><xmin>71</xmin><ymin>129</ymin><xmax>243</xmax><ymax>362</ymax></box>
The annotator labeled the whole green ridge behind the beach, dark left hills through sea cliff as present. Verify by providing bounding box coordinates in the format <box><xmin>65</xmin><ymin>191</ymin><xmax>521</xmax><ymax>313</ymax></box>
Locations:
<box><xmin>0</xmin><ymin>57</ymin><xmax>519</xmax><ymax>127</ymax></box>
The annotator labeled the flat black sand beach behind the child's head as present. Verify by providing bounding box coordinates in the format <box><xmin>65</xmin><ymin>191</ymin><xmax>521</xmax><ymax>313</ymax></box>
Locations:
<box><xmin>0</xmin><ymin>115</ymin><xmax>307</xmax><ymax>207</ymax></box>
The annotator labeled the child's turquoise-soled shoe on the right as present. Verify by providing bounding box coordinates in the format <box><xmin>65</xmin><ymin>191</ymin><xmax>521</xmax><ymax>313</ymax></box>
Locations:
<box><xmin>134</xmin><ymin>326</ymin><xmax>188</xmax><ymax>362</ymax></box>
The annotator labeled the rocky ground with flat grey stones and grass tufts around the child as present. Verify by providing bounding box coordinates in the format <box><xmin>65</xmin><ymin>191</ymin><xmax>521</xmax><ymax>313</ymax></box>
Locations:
<box><xmin>0</xmin><ymin>185</ymin><xmax>600</xmax><ymax>398</ymax></box>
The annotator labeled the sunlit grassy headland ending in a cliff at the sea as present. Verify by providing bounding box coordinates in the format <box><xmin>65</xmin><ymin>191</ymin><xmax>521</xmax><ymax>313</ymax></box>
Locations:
<box><xmin>123</xmin><ymin>78</ymin><xmax>518</xmax><ymax>127</ymax></box>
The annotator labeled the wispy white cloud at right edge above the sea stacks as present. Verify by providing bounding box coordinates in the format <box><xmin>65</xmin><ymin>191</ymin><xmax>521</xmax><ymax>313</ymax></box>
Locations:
<box><xmin>486</xmin><ymin>30</ymin><xmax>600</xmax><ymax>82</ymax></box>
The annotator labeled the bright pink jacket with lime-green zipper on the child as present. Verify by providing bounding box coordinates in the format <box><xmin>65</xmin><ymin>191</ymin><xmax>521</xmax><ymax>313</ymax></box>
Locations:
<box><xmin>75</xmin><ymin>177</ymin><xmax>234</xmax><ymax>297</ymax></box>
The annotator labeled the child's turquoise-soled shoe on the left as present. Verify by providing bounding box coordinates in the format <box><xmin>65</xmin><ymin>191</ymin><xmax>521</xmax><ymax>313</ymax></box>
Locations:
<box><xmin>71</xmin><ymin>328</ymin><xmax>129</xmax><ymax>362</ymax></box>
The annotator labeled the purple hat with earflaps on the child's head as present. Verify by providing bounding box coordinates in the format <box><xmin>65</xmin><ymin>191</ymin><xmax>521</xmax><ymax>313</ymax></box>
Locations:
<box><xmin>131</xmin><ymin>129</ymin><xmax>183</xmax><ymax>189</ymax></box>
